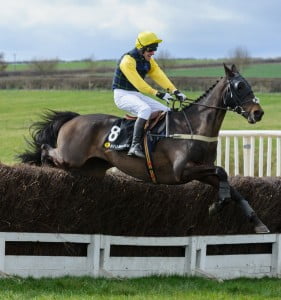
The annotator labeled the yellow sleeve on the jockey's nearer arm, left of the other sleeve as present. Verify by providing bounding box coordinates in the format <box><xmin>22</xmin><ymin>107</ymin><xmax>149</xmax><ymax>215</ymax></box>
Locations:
<box><xmin>120</xmin><ymin>54</ymin><xmax>157</xmax><ymax>96</ymax></box>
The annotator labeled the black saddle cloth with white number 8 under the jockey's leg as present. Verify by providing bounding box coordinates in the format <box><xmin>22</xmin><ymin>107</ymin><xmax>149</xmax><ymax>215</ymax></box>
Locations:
<box><xmin>103</xmin><ymin>114</ymin><xmax>166</xmax><ymax>151</ymax></box>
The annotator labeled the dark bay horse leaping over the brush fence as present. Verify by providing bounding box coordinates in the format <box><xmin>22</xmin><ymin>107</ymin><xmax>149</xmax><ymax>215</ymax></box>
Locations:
<box><xmin>19</xmin><ymin>65</ymin><xmax>269</xmax><ymax>233</ymax></box>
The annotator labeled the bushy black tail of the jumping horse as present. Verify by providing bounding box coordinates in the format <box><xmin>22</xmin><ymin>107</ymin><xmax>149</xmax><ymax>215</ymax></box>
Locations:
<box><xmin>17</xmin><ymin>110</ymin><xmax>79</xmax><ymax>165</ymax></box>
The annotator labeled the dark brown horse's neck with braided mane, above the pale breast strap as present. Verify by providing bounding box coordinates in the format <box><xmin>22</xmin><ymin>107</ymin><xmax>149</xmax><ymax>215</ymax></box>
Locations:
<box><xmin>183</xmin><ymin>78</ymin><xmax>226</xmax><ymax>136</ymax></box>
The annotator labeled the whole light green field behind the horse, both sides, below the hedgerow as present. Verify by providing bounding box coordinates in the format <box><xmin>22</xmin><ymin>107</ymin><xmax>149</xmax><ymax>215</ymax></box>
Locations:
<box><xmin>0</xmin><ymin>90</ymin><xmax>281</xmax><ymax>164</ymax></box>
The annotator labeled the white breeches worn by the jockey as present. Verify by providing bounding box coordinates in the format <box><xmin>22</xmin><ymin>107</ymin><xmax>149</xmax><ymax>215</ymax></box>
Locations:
<box><xmin>114</xmin><ymin>89</ymin><xmax>170</xmax><ymax>120</ymax></box>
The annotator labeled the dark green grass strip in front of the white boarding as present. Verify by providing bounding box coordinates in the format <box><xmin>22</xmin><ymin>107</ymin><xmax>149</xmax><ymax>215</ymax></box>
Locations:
<box><xmin>0</xmin><ymin>276</ymin><xmax>281</xmax><ymax>300</ymax></box>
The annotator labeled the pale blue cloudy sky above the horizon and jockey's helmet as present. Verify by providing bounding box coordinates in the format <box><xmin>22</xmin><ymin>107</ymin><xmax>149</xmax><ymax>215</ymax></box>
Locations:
<box><xmin>0</xmin><ymin>0</ymin><xmax>281</xmax><ymax>61</ymax></box>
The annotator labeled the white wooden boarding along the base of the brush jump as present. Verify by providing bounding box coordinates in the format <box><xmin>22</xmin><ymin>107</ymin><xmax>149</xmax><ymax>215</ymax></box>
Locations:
<box><xmin>0</xmin><ymin>232</ymin><xmax>281</xmax><ymax>279</ymax></box>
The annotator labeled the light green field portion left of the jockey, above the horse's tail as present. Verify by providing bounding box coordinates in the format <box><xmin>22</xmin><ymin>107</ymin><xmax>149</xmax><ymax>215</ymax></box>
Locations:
<box><xmin>0</xmin><ymin>90</ymin><xmax>120</xmax><ymax>164</ymax></box>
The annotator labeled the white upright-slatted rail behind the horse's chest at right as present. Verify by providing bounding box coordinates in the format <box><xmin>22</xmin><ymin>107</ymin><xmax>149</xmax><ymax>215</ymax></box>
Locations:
<box><xmin>216</xmin><ymin>130</ymin><xmax>281</xmax><ymax>177</ymax></box>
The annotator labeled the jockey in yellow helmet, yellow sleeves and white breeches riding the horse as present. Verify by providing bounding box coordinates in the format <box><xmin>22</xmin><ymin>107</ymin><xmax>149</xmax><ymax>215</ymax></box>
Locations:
<box><xmin>112</xmin><ymin>31</ymin><xmax>186</xmax><ymax>158</ymax></box>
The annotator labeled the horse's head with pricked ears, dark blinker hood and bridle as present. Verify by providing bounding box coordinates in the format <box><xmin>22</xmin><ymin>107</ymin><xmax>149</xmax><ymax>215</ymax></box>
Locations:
<box><xmin>224</xmin><ymin>64</ymin><xmax>264</xmax><ymax>124</ymax></box>
